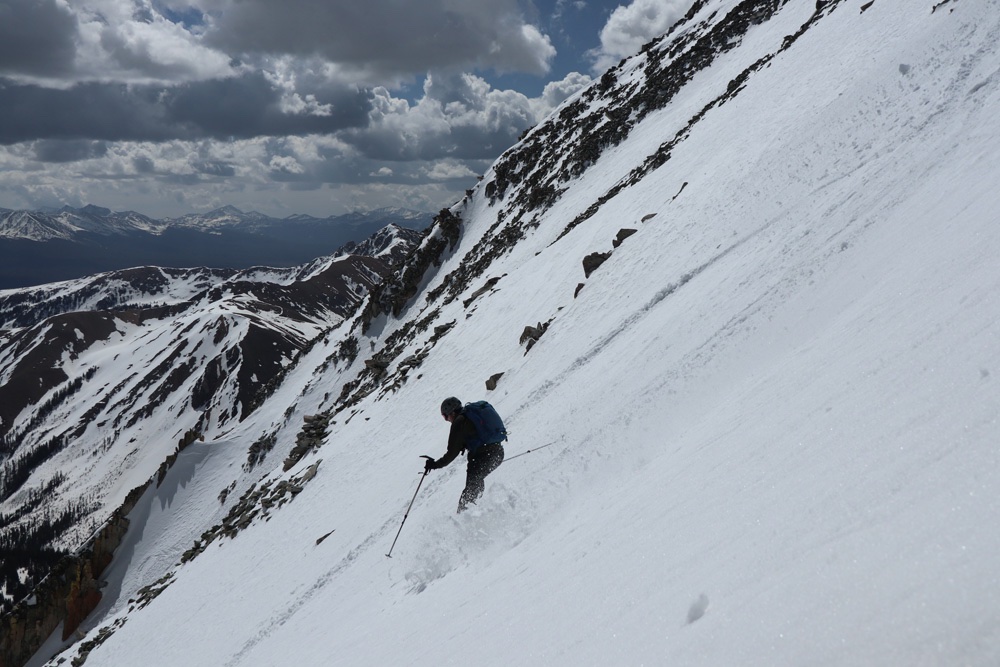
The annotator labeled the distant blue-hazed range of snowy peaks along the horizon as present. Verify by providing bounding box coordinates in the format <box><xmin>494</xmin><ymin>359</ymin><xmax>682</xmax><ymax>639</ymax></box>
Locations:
<box><xmin>0</xmin><ymin>205</ymin><xmax>433</xmax><ymax>289</ymax></box>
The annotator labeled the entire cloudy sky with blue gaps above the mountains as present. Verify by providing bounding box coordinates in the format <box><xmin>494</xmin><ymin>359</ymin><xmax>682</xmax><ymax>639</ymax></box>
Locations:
<box><xmin>0</xmin><ymin>0</ymin><xmax>691</xmax><ymax>217</ymax></box>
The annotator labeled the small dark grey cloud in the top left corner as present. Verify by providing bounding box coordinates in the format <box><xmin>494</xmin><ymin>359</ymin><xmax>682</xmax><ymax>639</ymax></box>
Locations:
<box><xmin>0</xmin><ymin>0</ymin><xmax>77</xmax><ymax>76</ymax></box>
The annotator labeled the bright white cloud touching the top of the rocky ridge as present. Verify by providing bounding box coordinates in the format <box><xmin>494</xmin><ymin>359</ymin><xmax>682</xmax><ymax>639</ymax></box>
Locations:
<box><xmin>590</xmin><ymin>0</ymin><xmax>691</xmax><ymax>74</ymax></box>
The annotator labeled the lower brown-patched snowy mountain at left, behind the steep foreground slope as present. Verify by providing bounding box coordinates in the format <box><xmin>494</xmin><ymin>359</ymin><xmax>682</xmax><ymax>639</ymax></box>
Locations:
<box><xmin>0</xmin><ymin>226</ymin><xmax>421</xmax><ymax>648</ymax></box>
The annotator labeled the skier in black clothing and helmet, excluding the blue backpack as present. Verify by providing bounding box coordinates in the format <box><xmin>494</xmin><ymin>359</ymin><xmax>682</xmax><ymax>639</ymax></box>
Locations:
<box><xmin>424</xmin><ymin>396</ymin><xmax>505</xmax><ymax>514</ymax></box>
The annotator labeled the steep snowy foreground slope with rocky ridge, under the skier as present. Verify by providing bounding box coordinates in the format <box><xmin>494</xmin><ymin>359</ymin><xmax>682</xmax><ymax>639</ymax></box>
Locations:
<box><xmin>3</xmin><ymin>0</ymin><xmax>1000</xmax><ymax>667</ymax></box>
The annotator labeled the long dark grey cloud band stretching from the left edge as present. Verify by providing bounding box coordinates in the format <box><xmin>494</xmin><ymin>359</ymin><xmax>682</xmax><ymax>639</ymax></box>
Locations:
<box><xmin>0</xmin><ymin>74</ymin><xmax>370</xmax><ymax>145</ymax></box>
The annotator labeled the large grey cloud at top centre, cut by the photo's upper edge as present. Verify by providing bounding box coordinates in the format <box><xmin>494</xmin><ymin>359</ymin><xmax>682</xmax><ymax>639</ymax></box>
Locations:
<box><xmin>206</xmin><ymin>0</ymin><xmax>555</xmax><ymax>74</ymax></box>
